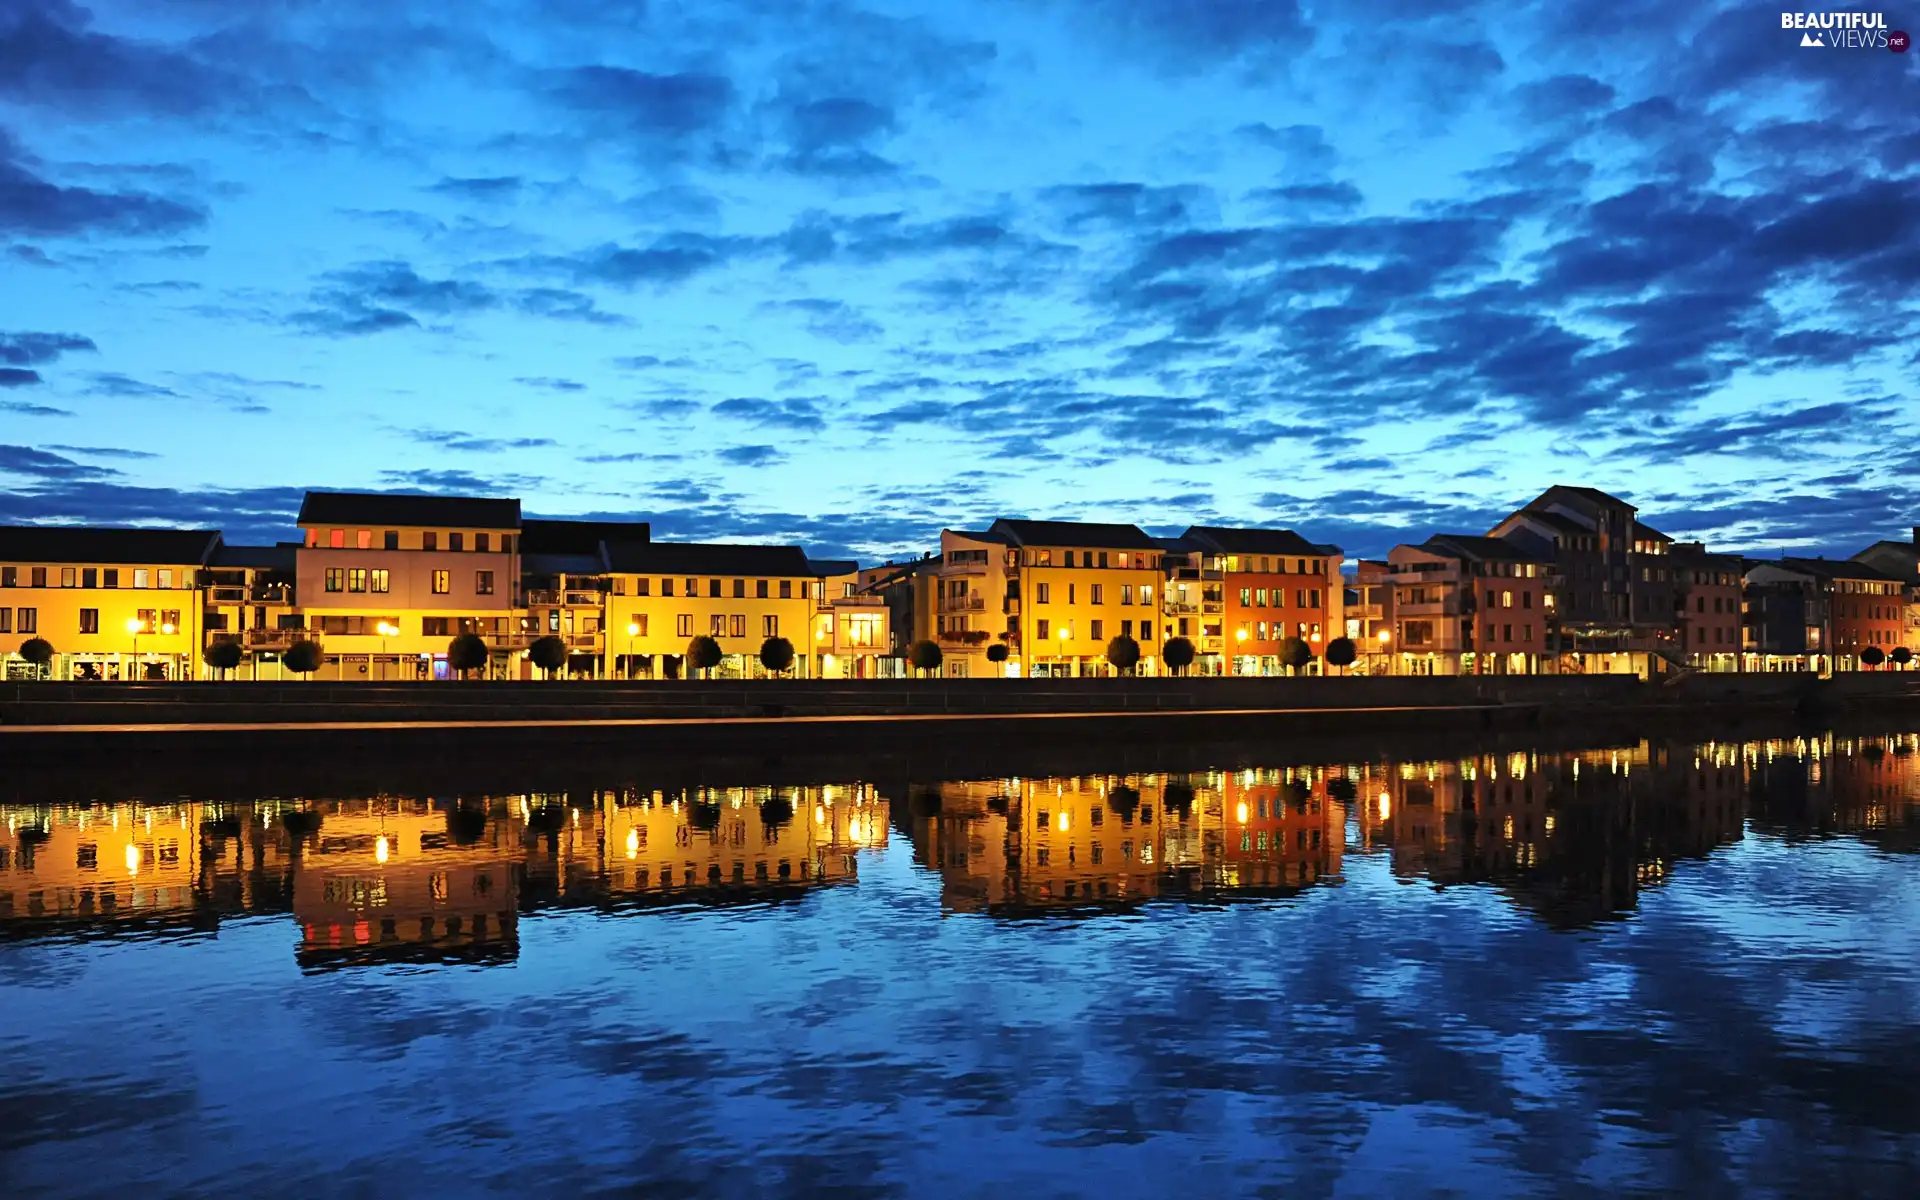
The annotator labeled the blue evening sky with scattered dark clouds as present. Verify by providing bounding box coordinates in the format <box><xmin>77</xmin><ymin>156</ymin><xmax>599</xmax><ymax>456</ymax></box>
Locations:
<box><xmin>0</xmin><ymin>0</ymin><xmax>1920</xmax><ymax>561</ymax></box>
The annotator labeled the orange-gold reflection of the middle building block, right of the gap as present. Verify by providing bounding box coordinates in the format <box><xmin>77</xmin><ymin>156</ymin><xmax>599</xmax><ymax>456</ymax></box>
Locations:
<box><xmin>914</xmin><ymin>770</ymin><xmax>1346</xmax><ymax>914</ymax></box>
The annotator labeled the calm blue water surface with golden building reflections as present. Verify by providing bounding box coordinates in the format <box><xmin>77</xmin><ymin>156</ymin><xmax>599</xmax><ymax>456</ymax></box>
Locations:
<box><xmin>0</xmin><ymin>733</ymin><xmax>1920</xmax><ymax>1196</ymax></box>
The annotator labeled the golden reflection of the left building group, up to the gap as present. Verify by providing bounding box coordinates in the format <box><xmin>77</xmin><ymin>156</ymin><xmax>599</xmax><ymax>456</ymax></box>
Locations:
<box><xmin>0</xmin><ymin>783</ymin><xmax>887</xmax><ymax>970</ymax></box>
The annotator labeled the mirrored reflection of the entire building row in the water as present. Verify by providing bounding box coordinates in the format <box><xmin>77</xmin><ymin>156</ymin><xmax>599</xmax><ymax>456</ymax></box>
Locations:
<box><xmin>0</xmin><ymin>733</ymin><xmax>1920</xmax><ymax>944</ymax></box>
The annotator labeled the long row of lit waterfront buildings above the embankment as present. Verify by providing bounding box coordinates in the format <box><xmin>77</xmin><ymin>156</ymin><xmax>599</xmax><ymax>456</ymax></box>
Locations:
<box><xmin>0</xmin><ymin>486</ymin><xmax>1920</xmax><ymax>682</ymax></box>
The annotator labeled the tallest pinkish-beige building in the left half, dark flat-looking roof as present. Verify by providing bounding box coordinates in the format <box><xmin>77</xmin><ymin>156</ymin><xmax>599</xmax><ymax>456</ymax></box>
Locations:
<box><xmin>291</xmin><ymin>492</ymin><xmax>530</xmax><ymax>680</ymax></box>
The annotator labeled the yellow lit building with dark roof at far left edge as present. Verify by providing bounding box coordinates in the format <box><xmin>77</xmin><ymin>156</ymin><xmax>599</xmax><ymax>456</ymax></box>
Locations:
<box><xmin>0</xmin><ymin>526</ymin><xmax>221</xmax><ymax>682</ymax></box>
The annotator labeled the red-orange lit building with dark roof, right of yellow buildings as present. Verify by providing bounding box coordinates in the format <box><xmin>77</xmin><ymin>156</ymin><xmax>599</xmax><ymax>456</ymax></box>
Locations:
<box><xmin>1181</xmin><ymin>524</ymin><xmax>1346</xmax><ymax>676</ymax></box>
